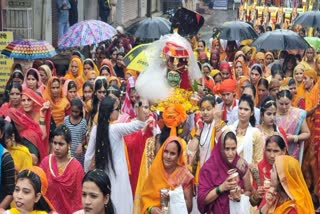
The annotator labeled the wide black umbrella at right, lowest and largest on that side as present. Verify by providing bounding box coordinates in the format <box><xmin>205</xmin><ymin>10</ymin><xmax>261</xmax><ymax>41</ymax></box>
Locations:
<box><xmin>251</xmin><ymin>30</ymin><xmax>309</xmax><ymax>50</ymax></box>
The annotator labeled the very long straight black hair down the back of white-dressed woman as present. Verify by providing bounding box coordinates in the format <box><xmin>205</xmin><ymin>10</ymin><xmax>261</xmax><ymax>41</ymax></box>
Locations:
<box><xmin>95</xmin><ymin>96</ymin><xmax>116</xmax><ymax>174</ymax></box>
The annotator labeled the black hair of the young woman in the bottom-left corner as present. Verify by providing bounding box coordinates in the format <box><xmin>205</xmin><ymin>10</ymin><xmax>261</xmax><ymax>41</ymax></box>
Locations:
<box><xmin>17</xmin><ymin>169</ymin><xmax>52</xmax><ymax>213</ymax></box>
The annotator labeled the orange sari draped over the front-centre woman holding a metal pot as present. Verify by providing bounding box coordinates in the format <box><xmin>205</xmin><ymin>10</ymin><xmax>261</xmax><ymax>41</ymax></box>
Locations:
<box><xmin>140</xmin><ymin>136</ymin><xmax>193</xmax><ymax>213</ymax></box>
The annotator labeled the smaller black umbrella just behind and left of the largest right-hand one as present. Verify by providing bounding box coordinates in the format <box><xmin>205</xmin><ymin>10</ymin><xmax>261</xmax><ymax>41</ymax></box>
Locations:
<box><xmin>219</xmin><ymin>21</ymin><xmax>258</xmax><ymax>41</ymax></box>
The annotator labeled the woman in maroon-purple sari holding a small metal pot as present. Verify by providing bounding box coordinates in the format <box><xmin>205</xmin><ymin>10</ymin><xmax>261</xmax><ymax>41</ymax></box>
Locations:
<box><xmin>197</xmin><ymin>129</ymin><xmax>251</xmax><ymax>214</ymax></box>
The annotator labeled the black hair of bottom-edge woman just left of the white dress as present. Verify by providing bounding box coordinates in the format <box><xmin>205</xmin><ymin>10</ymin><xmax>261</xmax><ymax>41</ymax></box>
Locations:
<box><xmin>82</xmin><ymin>169</ymin><xmax>115</xmax><ymax>214</ymax></box>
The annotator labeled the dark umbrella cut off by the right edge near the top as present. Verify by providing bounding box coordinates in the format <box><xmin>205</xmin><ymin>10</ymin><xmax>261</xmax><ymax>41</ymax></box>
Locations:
<box><xmin>294</xmin><ymin>11</ymin><xmax>320</xmax><ymax>28</ymax></box>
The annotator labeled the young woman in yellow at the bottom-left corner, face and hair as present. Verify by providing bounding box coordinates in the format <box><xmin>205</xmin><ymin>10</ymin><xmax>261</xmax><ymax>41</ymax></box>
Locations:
<box><xmin>0</xmin><ymin>169</ymin><xmax>52</xmax><ymax>214</ymax></box>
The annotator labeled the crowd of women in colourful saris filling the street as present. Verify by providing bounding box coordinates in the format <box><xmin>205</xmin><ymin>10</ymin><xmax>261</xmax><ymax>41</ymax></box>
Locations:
<box><xmin>0</xmin><ymin>22</ymin><xmax>320</xmax><ymax>214</ymax></box>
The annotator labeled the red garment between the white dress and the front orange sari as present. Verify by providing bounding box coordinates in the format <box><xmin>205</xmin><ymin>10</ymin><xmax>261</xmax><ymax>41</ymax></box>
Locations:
<box><xmin>124</xmin><ymin>128</ymin><xmax>152</xmax><ymax>196</ymax></box>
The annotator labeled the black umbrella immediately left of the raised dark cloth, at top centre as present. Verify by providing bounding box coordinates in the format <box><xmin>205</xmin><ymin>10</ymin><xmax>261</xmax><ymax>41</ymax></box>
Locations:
<box><xmin>128</xmin><ymin>17</ymin><xmax>171</xmax><ymax>39</ymax></box>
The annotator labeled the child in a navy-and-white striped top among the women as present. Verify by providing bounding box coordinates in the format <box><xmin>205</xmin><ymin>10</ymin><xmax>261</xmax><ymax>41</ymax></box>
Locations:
<box><xmin>64</xmin><ymin>98</ymin><xmax>88</xmax><ymax>165</ymax></box>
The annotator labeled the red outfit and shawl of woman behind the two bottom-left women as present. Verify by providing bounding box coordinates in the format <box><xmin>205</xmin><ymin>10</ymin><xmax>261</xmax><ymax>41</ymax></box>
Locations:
<box><xmin>40</xmin><ymin>155</ymin><xmax>84</xmax><ymax>214</ymax></box>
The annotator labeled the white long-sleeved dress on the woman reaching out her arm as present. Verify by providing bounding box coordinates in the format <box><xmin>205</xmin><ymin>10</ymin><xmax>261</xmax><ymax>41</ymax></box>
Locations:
<box><xmin>84</xmin><ymin>120</ymin><xmax>145</xmax><ymax>214</ymax></box>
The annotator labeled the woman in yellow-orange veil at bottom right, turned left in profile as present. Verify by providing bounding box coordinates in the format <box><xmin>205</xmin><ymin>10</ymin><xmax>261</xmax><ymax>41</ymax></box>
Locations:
<box><xmin>257</xmin><ymin>155</ymin><xmax>315</xmax><ymax>214</ymax></box>
